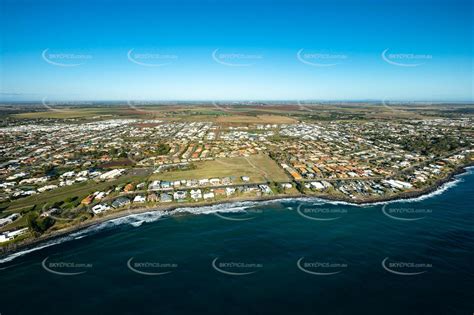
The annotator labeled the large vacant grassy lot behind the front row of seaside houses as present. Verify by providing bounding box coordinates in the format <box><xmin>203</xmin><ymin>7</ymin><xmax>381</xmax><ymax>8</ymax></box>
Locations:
<box><xmin>151</xmin><ymin>154</ymin><xmax>288</xmax><ymax>183</ymax></box>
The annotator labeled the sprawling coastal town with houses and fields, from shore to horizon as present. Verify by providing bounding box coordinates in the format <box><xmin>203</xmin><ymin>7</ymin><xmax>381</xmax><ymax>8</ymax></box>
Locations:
<box><xmin>0</xmin><ymin>103</ymin><xmax>474</xmax><ymax>250</ymax></box>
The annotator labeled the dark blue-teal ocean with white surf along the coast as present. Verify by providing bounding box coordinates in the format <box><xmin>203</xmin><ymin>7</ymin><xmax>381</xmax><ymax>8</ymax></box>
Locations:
<box><xmin>0</xmin><ymin>168</ymin><xmax>474</xmax><ymax>315</ymax></box>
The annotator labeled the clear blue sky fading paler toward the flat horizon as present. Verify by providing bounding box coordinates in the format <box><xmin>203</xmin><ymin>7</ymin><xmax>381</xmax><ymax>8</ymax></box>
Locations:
<box><xmin>0</xmin><ymin>0</ymin><xmax>474</xmax><ymax>102</ymax></box>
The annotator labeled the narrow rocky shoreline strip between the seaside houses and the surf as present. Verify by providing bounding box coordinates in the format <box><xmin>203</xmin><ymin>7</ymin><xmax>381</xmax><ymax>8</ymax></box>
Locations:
<box><xmin>0</xmin><ymin>163</ymin><xmax>474</xmax><ymax>259</ymax></box>
